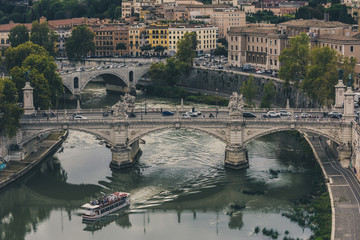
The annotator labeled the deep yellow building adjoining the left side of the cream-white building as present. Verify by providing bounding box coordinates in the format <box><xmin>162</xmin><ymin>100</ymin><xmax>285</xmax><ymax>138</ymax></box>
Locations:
<box><xmin>146</xmin><ymin>24</ymin><xmax>169</xmax><ymax>49</ymax></box>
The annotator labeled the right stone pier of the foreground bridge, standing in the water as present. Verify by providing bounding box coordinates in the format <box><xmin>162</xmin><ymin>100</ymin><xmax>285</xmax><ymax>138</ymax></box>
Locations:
<box><xmin>224</xmin><ymin>145</ymin><xmax>249</xmax><ymax>169</ymax></box>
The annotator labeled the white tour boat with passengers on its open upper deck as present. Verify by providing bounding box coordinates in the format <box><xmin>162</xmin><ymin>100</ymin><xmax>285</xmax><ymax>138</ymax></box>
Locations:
<box><xmin>81</xmin><ymin>192</ymin><xmax>130</xmax><ymax>221</ymax></box>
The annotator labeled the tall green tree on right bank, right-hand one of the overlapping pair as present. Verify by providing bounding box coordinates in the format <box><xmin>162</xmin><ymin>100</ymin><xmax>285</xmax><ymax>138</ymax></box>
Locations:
<box><xmin>302</xmin><ymin>47</ymin><xmax>338</xmax><ymax>106</ymax></box>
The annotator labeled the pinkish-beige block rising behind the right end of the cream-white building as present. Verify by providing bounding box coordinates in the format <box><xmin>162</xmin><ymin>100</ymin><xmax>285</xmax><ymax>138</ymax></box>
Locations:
<box><xmin>211</xmin><ymin>11</ymin><xmax>246</xmax><ymax>38</ymax></box>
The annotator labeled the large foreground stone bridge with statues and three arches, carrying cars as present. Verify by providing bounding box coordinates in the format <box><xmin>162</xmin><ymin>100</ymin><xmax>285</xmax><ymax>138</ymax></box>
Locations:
<box><xmin>16</xmin><ymin>79</ymin><xmax>360</xmax><ymax>174</ymax></box>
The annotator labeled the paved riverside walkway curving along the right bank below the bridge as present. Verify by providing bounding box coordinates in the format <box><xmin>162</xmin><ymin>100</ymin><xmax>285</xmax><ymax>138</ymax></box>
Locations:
<box><xmin>307</xmin><ymin>134</ymin><xmax>360</xmax><ymax>240</ymax></box>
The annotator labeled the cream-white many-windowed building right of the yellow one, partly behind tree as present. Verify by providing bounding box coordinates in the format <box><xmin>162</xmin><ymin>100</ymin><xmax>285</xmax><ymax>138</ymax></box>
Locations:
<box><xmin>169</xmin><ymin>26</ymin><xmax>218</xmax><ymax>55</ymax></box>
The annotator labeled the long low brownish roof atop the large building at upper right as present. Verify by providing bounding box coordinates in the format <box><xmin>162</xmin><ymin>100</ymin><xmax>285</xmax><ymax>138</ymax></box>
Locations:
<box><xmin>278</xmin><ymin>19</ymin><xmax>350</xmax><ymax>28</ymax></box>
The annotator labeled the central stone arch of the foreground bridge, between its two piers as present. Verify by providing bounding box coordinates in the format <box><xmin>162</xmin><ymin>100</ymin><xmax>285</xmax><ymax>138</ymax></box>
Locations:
<box><xmin>129</xmin><ymin>125</ymin><xmax>227</xmax><ymax>145</ymax></box>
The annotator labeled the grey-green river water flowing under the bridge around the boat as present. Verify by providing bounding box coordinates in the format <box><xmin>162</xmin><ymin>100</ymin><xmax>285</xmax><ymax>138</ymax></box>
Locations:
<box><xmin>0</xmin><ymin>83</ymin><xmax>321</xmax><ymax>240</ymax></box>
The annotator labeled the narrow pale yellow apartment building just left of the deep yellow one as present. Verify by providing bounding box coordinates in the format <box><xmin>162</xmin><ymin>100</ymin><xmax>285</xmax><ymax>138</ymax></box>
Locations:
<box><xmin>128</xmin><ymin>25</ymin><xmax>146</xmax><ymax>57</ymax></box>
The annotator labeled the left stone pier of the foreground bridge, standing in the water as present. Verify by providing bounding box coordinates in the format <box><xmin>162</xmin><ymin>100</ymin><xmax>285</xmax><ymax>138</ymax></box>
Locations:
<box><xmin>110</xmin><ymin>140</ymin><xmax>142</xmax><ymax>169</ymax></box>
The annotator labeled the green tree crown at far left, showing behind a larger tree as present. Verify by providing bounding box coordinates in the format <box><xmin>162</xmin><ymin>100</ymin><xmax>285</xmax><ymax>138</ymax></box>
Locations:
<box><xmin>5</xmin><ymin>42</ymin><xmax>49</xmax><ymax>70</ymax></box>
